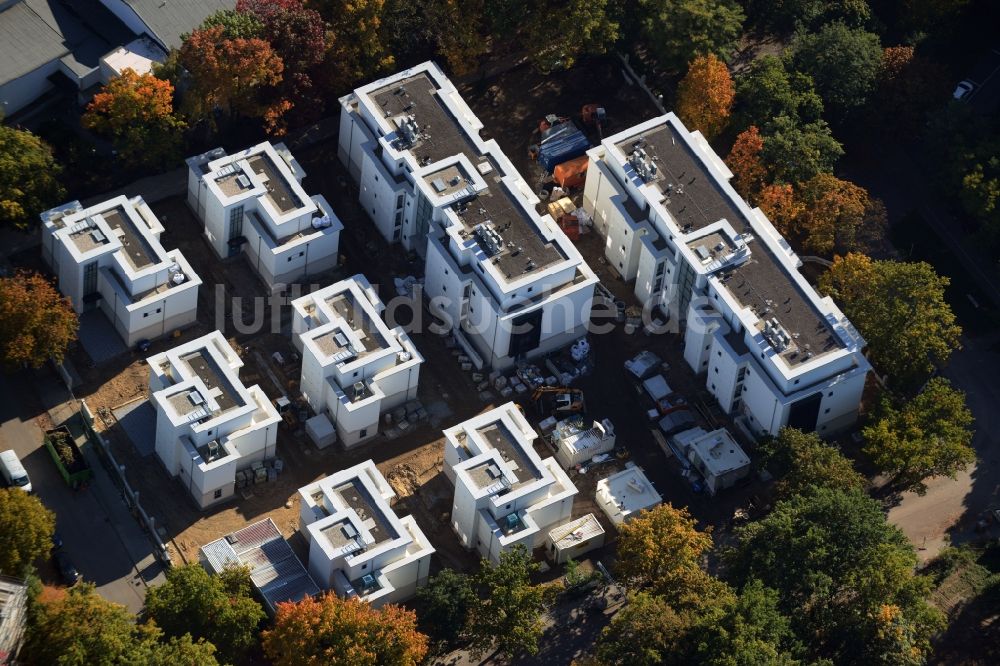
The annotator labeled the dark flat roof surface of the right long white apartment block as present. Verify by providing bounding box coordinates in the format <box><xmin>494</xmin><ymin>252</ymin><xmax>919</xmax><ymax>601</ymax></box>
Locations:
<box><xmin>615</xmin><ymin>121</ymin><xmax>843</xmax><ymax>365</ymax></box>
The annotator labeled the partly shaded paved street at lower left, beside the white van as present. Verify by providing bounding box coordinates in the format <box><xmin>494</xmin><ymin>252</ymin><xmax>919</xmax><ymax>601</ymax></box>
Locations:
<box><xmin>0</xmin><ymin>374</ymin><xmax>162</xmax><ymax>613</ymax></box>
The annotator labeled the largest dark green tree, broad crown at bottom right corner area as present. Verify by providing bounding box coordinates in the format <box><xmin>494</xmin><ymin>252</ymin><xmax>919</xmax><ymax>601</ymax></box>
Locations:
<box><xmin>725</xmin><ymin>488</ymin><xmax>943</xmax><ymax>663</ymax></box>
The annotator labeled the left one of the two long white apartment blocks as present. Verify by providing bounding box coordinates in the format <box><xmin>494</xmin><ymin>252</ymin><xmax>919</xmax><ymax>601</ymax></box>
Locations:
<box><xmin>338</xmin><ymin>62</ymin><xmax>597</xmax><ymax>368</ymax></box>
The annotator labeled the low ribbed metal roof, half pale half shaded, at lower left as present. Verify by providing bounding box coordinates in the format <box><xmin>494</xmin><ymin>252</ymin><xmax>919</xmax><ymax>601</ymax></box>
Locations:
<box><xmin>201</xmin><ymin>518</ymin><xmax>320</xmax><ymax>613</ymax></box>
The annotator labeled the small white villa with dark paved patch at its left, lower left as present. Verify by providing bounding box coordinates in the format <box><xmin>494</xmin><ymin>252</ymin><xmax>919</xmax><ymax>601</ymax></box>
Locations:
<box><xmin>146</xmin><ymin>331</ymin><xmax>281</xmax><ymax>508</ymax></box>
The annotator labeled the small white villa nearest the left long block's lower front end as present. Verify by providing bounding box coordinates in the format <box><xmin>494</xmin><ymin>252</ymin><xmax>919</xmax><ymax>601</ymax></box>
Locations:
<box><xmin>292</xmin><ymin>274</ymin><xmax>424</xmax><ymax>447</ymax></box>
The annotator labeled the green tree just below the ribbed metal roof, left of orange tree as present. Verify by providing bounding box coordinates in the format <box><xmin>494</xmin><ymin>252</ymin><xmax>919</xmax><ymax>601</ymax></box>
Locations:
<box><xmin>146</xmin><ymin>564</ymin><xmax>264</xmax><ymax>661</ymax></box>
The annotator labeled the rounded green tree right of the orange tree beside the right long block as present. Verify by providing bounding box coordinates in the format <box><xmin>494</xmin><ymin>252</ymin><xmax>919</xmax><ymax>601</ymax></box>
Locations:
<box><xmin>761</xmin><ymin>116</ymin><xmax>844</xmax><ymax>184</ymax></box>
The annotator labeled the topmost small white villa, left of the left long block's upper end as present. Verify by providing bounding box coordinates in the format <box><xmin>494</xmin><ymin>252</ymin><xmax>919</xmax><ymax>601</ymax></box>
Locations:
<box><xmin>187</xmin><ymin>142</ymin><xmax>344</xmax><ymax>291</ymax></box>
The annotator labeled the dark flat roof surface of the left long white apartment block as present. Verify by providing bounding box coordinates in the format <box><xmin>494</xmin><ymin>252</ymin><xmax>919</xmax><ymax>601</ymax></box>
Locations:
<box><xmin>370</xmin><ymin>72</ymin><xmax>566</xmax><ymax>279</ymax></box>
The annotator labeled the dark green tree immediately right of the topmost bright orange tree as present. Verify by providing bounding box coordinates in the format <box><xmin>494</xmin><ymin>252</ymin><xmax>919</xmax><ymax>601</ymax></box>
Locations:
<box><xmin>736</xmin><ymin>55</ymin><xmax>823</xmax><ymax>133</ymax></box>
